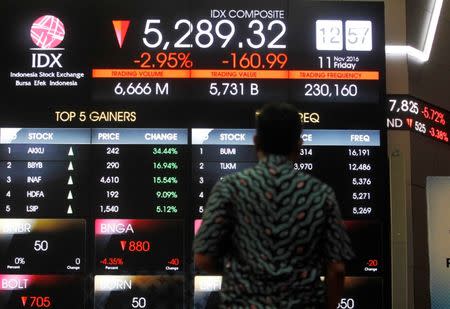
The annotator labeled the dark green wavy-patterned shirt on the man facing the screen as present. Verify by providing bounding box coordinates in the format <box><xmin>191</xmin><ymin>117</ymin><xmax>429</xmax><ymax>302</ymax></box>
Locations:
<box><xmin>194</xmin><ymin>155</ymin><xmax>353</xmax><ymax>309</ymax></box>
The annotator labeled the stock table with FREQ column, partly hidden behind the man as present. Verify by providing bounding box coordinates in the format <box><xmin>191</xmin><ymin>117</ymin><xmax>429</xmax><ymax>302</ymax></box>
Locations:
<box><xmin>192</xmin><ymin>129</ymin><xmax>382</xmax><ymax>219</ymax></box>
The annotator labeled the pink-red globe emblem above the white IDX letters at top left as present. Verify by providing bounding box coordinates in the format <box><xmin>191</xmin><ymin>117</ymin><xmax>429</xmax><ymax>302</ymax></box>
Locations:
<box><xmin>30</xmin><ymin>15</ymin><xmax>66</xmax><ymax>48</ymax></box>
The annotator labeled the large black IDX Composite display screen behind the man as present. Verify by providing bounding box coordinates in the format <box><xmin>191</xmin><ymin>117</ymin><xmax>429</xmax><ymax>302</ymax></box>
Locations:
<box><xmin>0</xmin><ymin>0</ymin><xmax>388</xmax><ymax>309</ymax></box>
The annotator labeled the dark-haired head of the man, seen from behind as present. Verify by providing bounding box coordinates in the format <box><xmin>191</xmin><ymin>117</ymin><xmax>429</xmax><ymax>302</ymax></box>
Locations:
<box><xmin>254</xmin><ymin>103</ymin><xmax>302</xmax><ymax>155</ymax></box>
